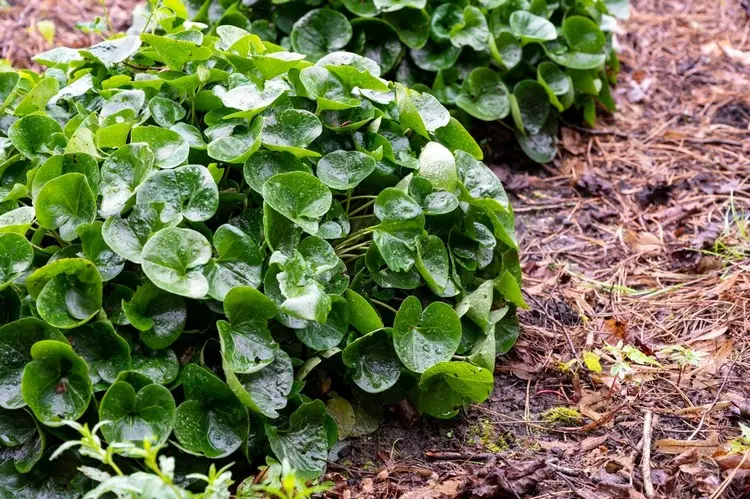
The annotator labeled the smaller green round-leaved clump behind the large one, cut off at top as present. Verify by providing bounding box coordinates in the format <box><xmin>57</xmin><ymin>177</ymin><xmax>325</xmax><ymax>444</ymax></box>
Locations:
<box><xmin>145</xmin><ymin>0</ymin><xmax>629</xmax><ymax>163</ymax></box>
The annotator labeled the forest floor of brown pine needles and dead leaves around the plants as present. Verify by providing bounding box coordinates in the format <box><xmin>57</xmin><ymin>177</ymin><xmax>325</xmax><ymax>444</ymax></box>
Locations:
<box><xmin>0</xmin><ymin>0</ymin><xmax>750</xmax><ymax>499</ymax></box>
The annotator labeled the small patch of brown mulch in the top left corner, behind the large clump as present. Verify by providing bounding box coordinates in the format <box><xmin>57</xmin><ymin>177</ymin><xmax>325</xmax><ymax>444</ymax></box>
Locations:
<box><xmin>0</xmin><ymin>0</ymin><xmax>138</xmax><ymax>69</ymax></box>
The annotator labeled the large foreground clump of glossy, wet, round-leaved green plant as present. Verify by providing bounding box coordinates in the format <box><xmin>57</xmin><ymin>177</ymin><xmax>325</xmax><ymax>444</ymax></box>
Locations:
<box><xmin>0</xmin><ymin>20</ymin><xmax>525</xmax><ymax>497</ymax></box>
